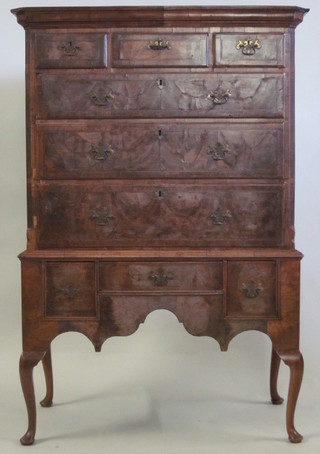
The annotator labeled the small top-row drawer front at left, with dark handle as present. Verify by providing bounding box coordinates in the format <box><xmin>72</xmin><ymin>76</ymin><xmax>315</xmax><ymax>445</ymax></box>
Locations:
<box><xmin>35</xmin><ymin>33</ymin><xmax>107</xmax><ymax>68</ymax></box>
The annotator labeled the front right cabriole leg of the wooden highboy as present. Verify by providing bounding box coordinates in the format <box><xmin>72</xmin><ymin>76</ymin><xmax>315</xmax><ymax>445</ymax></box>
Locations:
<box><xmin>280</xmin><ymin>350</ymin><xmax>303</xmax><ymax>443</ymax></box>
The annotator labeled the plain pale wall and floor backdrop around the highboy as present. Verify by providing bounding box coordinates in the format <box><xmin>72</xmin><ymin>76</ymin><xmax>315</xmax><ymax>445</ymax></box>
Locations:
<box><xmin>0</xmin><ymin>0</ymin><xmax>320</xmax><ymax>454</ymax></box>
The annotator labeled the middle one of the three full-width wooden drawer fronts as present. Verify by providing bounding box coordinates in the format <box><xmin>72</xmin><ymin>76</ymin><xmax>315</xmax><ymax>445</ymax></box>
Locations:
<box><xmin>40</xmin><ymin>122</ymin><xmax>283</xmax><ymax>178</ymax></box>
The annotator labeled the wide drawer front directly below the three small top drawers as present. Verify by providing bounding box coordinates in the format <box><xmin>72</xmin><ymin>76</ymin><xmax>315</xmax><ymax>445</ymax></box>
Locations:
<box><xmin>38</xmin><ymin>73</ymin><xmax>283</xmax><ymax>119</ymax></box>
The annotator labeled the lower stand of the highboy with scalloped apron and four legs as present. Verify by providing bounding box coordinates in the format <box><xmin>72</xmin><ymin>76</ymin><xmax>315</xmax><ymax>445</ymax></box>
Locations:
<box><xmin>20</xmin><ymin>249</ymin><xmax>303</xmax><ymax>445</ymax></box>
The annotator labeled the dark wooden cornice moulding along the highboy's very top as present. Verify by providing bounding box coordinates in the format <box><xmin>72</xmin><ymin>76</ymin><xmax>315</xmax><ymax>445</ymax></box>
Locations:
<box><xmin>12</xmin><ymin>6</ymin><xmax>309</xmax><ymax>29</ymax></box>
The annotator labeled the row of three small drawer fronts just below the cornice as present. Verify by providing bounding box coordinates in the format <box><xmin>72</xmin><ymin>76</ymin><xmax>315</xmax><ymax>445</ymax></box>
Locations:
<box><xmin>35</xmin><ymin>33</ymin><xmax>284</xmax><ymax>69</ymax></box>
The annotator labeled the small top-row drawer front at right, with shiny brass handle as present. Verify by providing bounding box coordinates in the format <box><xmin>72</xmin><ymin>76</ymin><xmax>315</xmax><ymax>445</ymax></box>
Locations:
<box><xmin>215</xmin><ymin>33</ymin><xmax>284</xmax><ymax>66</ymax></box>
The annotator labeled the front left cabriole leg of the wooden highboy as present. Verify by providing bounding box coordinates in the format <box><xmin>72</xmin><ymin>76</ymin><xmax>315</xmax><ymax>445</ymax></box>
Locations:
<box><xmin>19</xmin><ymin>352</ymin><xmax>43</xmax><ymax>445</ymax></box>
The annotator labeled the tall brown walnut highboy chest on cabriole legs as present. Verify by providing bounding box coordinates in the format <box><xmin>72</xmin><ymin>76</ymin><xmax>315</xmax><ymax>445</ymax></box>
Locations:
<box><xmin>13</xmin><ymin>7</ymin><xmax>308</xmax><ymax>445</ymax></box>
